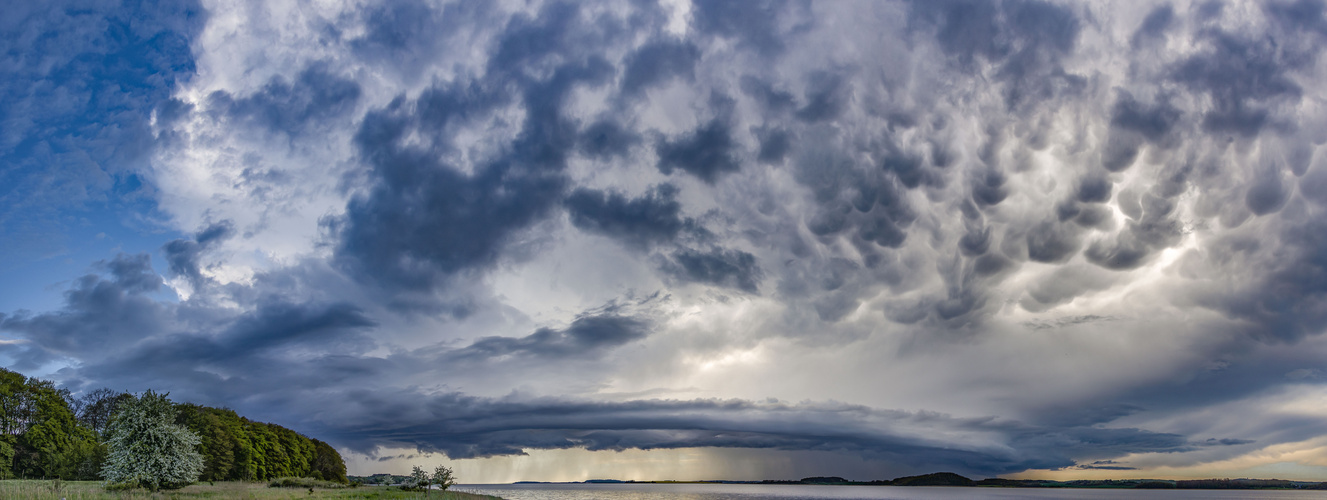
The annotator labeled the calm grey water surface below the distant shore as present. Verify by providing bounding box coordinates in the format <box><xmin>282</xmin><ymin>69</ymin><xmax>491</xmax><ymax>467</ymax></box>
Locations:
<box><xmin>456</xmin><ymin>484</ymin><xmax>1327</xmax><ymax>500</ymax></box>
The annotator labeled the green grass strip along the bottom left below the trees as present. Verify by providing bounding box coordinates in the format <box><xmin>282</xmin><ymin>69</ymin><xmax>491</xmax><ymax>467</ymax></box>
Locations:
<box><xmin>0</xmin><ymin>479</ymin><xmax>500</xmax><ymax>500</ymax></box>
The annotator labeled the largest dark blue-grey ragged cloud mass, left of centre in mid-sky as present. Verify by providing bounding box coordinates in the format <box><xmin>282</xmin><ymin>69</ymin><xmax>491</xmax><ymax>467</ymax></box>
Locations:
<box><xmin>337</xmin><ymin>56</ymin><xmax>606</xmax><ymax>302</ymax></box>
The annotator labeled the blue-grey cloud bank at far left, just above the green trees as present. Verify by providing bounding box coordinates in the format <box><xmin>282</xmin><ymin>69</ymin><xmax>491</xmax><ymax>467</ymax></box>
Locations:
<box><xmin>0</xmin><ymin>253</ymin><xmax>376</xmax><ymax>376</ymax></box>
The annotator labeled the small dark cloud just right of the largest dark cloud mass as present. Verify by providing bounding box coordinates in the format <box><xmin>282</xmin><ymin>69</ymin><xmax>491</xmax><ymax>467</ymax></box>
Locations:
<box><xmin>565</xmin><ymin>184</ymin><xmax>705</xmax><ymax>249</ymax></box>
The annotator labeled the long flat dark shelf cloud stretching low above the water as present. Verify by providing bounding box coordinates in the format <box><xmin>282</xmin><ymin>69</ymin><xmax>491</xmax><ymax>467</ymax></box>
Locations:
<box><xmin>303</xmin><ymin>393</ymin><xmax>1189</xmax><ymax>475</ymax></box>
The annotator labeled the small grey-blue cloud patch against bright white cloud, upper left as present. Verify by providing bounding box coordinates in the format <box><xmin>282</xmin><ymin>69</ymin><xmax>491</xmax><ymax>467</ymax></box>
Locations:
<box><xmin>207</xmin><ymin>64</ymin><xmax>361</xmax><ymax>135</ymax></box>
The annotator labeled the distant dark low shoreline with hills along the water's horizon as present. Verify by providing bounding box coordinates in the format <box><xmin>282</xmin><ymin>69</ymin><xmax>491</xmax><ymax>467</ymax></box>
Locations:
<box><xmin>480</xmin><ymin>472</ymin><xmax>1327</xmax><ymax>489</ymax></box>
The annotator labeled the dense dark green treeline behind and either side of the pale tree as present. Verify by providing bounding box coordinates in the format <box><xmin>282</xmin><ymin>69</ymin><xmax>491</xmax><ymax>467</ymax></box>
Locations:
<box><xmin>0</xmin><ymin>369</ymin><xmax>346</xmax><ymax>483</ymax></box>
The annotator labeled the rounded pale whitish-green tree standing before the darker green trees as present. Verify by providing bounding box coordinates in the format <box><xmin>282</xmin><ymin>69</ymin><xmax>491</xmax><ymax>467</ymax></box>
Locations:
<box><xmin>102</xmin><ymin>390</ymin><xmax>203</xmax><ymax>491</ymax></box>
